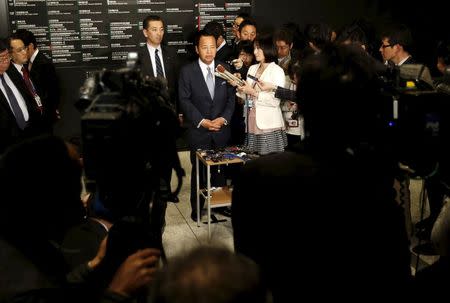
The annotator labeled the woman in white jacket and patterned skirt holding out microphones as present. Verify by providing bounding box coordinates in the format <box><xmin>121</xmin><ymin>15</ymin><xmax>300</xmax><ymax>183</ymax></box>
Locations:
<box><xmin>237</xmin><ymin>36</ymin><xmax>287</xmax><ymax>155</ymax></box>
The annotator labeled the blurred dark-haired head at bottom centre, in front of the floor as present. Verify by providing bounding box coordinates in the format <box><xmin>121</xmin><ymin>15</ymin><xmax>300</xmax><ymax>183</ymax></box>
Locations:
<box><xmin>152</xmin><ymin>246</ymin><xmax>270</xmax><ymax>303</ymax></box>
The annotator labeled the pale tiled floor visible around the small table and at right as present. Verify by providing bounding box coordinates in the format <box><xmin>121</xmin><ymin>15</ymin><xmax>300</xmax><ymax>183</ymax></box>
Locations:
<box><xmin>163</xmin><ymin>151</ymin><xmax>437</xmax><ymax>272</ymax></box>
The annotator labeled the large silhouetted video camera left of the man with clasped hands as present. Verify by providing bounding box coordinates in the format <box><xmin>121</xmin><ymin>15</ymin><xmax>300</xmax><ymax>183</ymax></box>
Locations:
<box><xmin>76</xmin><ymin>53</ymin><xmax>181</xmax><ymax>222</ymax></box>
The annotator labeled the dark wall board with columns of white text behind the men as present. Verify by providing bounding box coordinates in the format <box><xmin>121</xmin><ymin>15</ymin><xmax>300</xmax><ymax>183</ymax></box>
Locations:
<box><xmin>7</xmin><ymin>0</ymin><xmax>253</xmax><ymax>67</ymax></box>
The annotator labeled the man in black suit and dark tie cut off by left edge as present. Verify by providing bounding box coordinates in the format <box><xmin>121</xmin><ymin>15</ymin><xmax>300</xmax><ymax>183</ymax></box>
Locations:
<box><xmin>0</xmin><ymin>39</ymin><xmax>41</xmax><ymax>154</ymax></box>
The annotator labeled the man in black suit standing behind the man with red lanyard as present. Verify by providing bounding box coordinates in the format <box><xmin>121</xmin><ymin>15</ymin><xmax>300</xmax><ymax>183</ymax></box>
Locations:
<box><xmin>14</xmin><ymin>29</ymin><xmax>60</xmax><ymax>132</ymax></box>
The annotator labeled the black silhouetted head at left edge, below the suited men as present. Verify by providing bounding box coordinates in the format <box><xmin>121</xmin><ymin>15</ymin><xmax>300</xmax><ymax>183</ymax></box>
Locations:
<box><xmin>0</xmin><ymin>136</ymin><xmax>84</xmax><ymax>240</ymax></box>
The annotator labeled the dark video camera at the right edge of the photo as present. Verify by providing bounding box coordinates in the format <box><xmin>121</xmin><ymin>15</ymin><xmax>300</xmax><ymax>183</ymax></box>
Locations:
<box><xmin>380</xmin><ymin>64</ymin><xmax>450</xmax><ymax>176</ymax></box>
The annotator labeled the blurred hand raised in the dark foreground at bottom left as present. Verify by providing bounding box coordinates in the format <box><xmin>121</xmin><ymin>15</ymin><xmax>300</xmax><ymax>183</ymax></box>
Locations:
<box><xmin>108</xmin><ymin>248</ymin><xmax>161</xmax><ymax>296</ymax></box>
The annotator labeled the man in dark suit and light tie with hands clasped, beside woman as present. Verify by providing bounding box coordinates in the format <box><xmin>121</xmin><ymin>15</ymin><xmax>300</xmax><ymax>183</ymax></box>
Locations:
<box><xmin>178</xmin><ymin>30</ymin><xmax>235</xmax><ymax>221</ymax></box>
